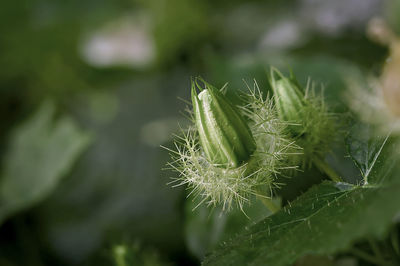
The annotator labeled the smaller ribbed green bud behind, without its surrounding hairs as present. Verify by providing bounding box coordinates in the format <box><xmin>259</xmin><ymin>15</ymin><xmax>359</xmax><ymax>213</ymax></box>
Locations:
<box><xmin>271</xmin><ymin>70</ymin><xmax>305</xmax><ymax>132</ymax></box>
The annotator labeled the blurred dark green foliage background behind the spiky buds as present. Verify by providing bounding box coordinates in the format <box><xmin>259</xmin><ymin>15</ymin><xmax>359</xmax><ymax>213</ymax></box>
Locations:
<box><xmin>0</xmin><ymin>0</ymin><xmax>400</xmax><ymax>266</ymax></box>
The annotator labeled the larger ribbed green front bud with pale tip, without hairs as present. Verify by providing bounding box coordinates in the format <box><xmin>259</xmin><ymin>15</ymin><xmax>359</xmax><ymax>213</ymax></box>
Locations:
<box><xmin>192</xmin><ymin>80</ymin><xmax>256</xmax><ymax>168</ymax></box>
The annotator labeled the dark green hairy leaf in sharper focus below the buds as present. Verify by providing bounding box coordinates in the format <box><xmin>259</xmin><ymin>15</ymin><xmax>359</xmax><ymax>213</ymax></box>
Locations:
<box><xmin>203</xmin><ymin>136</ymin><xmax>400</xmax><ymax>266</ymax></box>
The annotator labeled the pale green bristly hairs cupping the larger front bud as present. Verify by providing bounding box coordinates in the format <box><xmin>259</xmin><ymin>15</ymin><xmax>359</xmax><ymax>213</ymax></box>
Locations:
<box><xmin>164</xmin><ymin>80</ymin><xmax>301</xmax><ymax>210</ymax></box>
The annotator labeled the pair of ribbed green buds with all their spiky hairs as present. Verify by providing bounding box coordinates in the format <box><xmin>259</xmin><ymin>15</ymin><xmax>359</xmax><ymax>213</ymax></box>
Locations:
<box><xmin>169</xmin><ymin>69</ymin><xmax>333</xmax><ymax>209</ymax></box>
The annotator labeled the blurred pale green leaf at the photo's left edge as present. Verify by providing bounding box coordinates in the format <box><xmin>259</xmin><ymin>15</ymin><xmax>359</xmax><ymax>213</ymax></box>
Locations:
<box><xmin>0</xmin><ymin>103</ymin><xmax>90</xmax><ymax>224</ymax></box>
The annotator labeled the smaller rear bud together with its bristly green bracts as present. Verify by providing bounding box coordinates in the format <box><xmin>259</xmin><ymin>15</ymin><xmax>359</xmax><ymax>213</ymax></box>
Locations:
<box><xmin>270</xmin><ymin>68</ymin><xmax>338</xmax><ymax>168</ymax></box>
